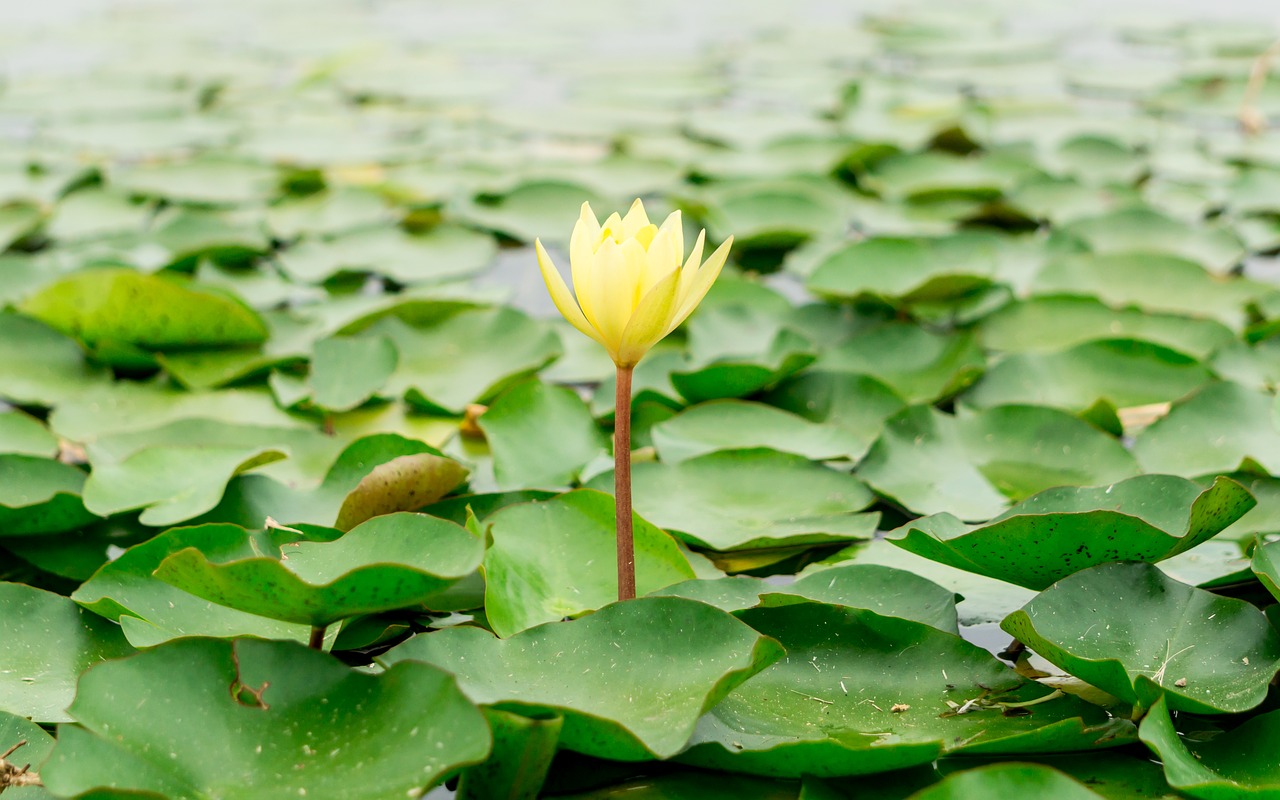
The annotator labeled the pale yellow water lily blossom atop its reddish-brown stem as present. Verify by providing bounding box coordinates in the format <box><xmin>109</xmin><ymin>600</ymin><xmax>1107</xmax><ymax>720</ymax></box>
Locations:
<box><xmin>536</xmin><ymin>200</ymin><xmax>733</xmax><ymax>369</ymax></box>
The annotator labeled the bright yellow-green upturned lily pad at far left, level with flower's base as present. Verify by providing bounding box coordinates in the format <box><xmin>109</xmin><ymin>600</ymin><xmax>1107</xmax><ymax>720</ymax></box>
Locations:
<box><xmin>22</xmin><ymin>269</ymin><xmax>268</xmax><ymax>349</ymax></box>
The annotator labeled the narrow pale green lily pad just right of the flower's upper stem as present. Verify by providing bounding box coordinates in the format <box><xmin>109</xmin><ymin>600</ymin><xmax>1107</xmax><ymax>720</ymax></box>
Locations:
<box><xmin>649</xmin><ymin>399</ymin><xmax>867</xmax><ymax>463</ymax></box>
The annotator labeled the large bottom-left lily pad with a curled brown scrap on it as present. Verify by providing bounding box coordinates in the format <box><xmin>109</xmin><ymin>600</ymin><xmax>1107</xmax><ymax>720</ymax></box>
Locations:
<box><xmin>41</xmin><ymin>639</ymin><xmax>492</xmax><ymax>800</ymax></box>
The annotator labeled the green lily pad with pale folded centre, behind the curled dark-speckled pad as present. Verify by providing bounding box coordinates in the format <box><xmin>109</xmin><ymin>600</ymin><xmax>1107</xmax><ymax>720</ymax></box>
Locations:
<box><xmin>858</xmin><ymin>406</ymin><xmax>1138</xmax><ymax>520</ymax></box>
